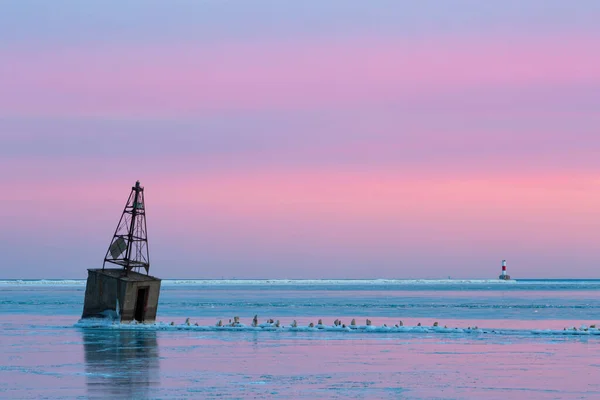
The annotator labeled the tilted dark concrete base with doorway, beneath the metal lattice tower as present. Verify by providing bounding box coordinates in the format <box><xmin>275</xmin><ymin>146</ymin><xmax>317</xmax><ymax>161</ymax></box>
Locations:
<box><xmin>81</xmin><ymin>269</ymin><xmax>160</xmax><ymax>323</ymax></box>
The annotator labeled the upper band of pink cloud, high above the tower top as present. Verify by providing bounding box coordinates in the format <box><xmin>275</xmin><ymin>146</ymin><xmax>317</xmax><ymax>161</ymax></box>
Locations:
<box><xmin>0</xmin><ymin>36</ymin><xmax>600</xmax><ymax>116</ymax></box>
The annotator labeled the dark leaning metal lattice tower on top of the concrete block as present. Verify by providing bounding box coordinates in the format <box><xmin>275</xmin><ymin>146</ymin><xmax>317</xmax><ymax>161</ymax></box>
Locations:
<box><xmin>102</xmin><ymin>181</ymin><xmax>150</xmax><ymax>274</ymax></box>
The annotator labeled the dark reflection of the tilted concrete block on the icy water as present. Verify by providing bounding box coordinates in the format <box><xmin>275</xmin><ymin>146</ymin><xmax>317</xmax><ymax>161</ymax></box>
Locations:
<box><xmin>82</xmin><ymin>330</ymin><xmax>160</xmax><ymax>398</ymax></box>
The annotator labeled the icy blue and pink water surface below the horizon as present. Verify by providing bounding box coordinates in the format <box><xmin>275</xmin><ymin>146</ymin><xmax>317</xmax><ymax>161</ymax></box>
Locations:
<box><xmin>0</xmin><ymin>281</ymin><xmax>600</xmax><ymax>399</ymax></box>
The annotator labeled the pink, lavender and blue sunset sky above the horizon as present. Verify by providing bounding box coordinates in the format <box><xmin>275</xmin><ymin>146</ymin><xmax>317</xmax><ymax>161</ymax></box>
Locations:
<box><xmin>0</xmin><ymin>0</ymin><xmax>600</xmax><ymax>279</ymax></box>
